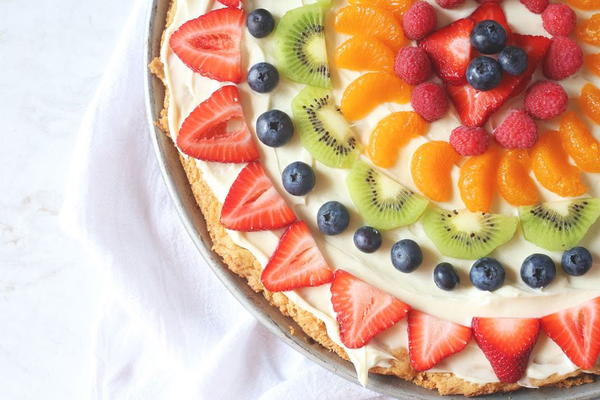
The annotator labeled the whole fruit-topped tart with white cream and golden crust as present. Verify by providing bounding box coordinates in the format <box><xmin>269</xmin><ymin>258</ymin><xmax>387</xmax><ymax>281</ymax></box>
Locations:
<box><xmin>150</xmin><ymin>0</ymin><xmax>600</xmax><ymax>396</ymax></box>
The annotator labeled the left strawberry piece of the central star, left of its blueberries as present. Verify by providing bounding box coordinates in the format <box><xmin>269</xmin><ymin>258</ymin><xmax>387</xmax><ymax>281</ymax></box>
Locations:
<box><xmin>419</xmin><ymin>18</ymin><xmax>475</xmax><ymax>85</ymax></box>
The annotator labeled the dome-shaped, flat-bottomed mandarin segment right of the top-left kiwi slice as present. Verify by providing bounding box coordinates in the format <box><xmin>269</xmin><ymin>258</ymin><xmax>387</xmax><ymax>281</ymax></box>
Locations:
<box><xmin>335</xmin><ymin>35</ymin><xmax>395</xmax><ymax>72</ymax></box>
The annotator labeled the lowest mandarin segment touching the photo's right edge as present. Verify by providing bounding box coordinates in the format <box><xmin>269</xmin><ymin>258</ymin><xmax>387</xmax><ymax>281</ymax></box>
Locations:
<box><xmin>560</xmin><ymin>111</ymin><xmax>600</xmax><ymax>172</ymax></box>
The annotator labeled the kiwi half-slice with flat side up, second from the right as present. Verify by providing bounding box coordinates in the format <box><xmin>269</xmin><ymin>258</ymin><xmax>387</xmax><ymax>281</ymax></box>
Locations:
<box><xmin>421</xmin><ymin>208</ymin><xmax>519</xmax><ymax>260</ymax></box>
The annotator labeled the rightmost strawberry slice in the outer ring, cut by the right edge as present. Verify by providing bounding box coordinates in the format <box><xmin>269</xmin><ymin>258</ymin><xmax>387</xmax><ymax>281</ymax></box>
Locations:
<box><xmin>542</xmin><ymin>297</ymin><xmax>600</xmax><ymax>370</ymax></box>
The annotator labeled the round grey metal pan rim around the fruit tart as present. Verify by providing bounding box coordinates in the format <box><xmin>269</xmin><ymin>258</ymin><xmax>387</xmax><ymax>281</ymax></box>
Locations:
<box><xmin>144</xmin><ymin>0</ymin><xmax>600</xmax><ymax>400</ymax></box>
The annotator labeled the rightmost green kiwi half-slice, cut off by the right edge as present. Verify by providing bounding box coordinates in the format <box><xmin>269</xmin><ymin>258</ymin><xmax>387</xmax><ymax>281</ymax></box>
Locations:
<box><xmin>519</xmin><ymin>198</ymin><xmax>600</xmax><ymax>251</ymax></box>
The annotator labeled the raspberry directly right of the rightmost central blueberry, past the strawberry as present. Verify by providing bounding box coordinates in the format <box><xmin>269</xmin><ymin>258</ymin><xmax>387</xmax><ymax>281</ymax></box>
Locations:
<box><xmin>544</xmin><ymin>36</ymin><xmax>583</xmax><ymax>81</ymax></box>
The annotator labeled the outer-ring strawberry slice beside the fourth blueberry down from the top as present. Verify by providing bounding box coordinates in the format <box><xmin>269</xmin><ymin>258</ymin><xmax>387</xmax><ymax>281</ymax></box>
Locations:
<box><xmin>221</xmin><ymin>161</ymin><xmax>296</xmax><ymax>232</ymax></box>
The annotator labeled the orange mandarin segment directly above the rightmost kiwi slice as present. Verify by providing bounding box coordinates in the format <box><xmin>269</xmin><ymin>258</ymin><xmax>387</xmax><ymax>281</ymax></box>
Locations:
<box><xmin>530</xmin><ymin>131</ymin><xmax>587</xmax><ymax>197</ymax></box>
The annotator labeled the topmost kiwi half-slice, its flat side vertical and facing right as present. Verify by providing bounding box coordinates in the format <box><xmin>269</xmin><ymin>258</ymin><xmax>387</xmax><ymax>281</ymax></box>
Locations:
<box><xmin>275</xmin><ymin>0</ymin><xmax>331</xmax><ymax>89</ymax></box>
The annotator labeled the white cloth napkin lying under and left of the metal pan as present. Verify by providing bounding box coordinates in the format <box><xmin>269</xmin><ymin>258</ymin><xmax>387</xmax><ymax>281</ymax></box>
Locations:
<box><xmin>63</xmin><ymin>0</ymin><xmax>384</xmax><ymax>400</ymax></box>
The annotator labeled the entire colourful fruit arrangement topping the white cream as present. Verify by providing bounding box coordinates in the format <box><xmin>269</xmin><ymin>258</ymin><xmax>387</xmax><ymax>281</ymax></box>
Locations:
<box><xmin>169</xmin><ymin>0</ymin><xmax>600</xmax><ymax>388</ymax></box>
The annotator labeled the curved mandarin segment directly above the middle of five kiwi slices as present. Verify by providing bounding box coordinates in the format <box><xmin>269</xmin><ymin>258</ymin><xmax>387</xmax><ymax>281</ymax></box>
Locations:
<box><xmin>367</xmin><ymin>111</ymin><xmax>429</xmax><ymax>168</ymax></box>
